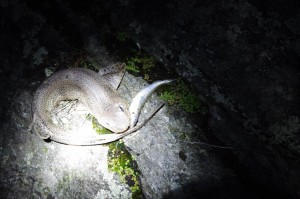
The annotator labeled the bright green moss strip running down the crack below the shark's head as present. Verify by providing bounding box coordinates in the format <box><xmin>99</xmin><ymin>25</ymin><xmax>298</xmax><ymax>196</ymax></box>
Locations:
<box><xmin>108</xmin><ymin>141</ymin><xmax>142</xmax><ymax>199</ymax></box>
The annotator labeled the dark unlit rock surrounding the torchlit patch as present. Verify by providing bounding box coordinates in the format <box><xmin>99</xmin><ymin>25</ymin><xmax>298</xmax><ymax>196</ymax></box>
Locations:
<box><xmin>0</xmin><ymin>0</ymin><xmax>300</xmax><ymax>198</ymax></box>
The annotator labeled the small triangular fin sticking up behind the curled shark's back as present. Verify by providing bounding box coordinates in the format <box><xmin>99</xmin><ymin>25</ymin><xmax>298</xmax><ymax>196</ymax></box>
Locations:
<box><xmin>98</xmin><ymin>63</ymin><xmax>126</xmax><ymax>89</ymax></box>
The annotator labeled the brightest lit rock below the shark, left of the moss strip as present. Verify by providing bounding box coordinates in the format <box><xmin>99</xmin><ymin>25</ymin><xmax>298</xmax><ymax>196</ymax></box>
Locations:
<box><xmin>0</xmin><ymin>91</ymin><xmax>131</xmax><ymax>198</ymax></box>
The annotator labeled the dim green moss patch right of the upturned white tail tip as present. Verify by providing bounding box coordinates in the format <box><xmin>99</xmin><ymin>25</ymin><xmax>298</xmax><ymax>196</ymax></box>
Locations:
<box><xmin>160</xmin><ymin>78</ymin><xmax>201</xmax><ymax>113</ymax></box>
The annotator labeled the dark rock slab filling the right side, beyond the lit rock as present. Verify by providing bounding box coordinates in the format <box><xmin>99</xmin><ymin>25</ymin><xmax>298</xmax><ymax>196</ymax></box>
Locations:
<box><xmin>99</xmin><ymin>1</ymin><xmax>300</xmax><ymax>198</ymax></box>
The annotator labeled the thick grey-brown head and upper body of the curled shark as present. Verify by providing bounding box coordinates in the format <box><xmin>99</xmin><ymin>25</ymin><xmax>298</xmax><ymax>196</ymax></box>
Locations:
<box><xmin>32</xmin><ymin>68</ymin><xmax>130</xmax><ymax>139</ymax></box>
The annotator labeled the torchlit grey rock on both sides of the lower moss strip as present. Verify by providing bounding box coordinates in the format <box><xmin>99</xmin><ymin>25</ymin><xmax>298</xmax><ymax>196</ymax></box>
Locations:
<box><xmin>0</xmin><ymin>74</ymin><xmax>219</xmax><ymax>198</ymax></box>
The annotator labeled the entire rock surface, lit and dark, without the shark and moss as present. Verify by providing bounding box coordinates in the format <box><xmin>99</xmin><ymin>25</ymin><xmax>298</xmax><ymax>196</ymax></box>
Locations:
<box><xmin>0</xmin><ymin>0</ymin><xmax>300</xmax><ymax>199</ymax></box>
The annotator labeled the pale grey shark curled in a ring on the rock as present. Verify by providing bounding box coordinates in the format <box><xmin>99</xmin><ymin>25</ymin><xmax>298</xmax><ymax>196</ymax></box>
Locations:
<box><xmin>32</xmin><ymin>64</ymin><xmax>171</xmax><ymax>145</ymax></box>
